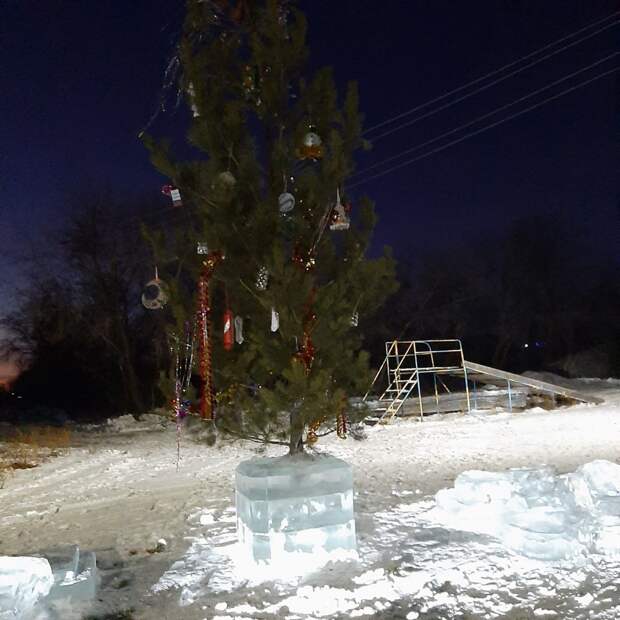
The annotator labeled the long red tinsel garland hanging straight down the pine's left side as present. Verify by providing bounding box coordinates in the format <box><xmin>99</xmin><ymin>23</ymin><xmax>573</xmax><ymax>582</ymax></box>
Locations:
<box><xmin>196</xmin><ymin>251</ymin><xmax>224</xmax><ymax>420</ymax></box>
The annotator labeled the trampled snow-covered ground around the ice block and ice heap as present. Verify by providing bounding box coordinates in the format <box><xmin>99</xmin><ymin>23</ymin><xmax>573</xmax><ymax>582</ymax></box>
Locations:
<box><xmin>0</xmin><ymin>380</ymin><xmax>620</xmax><ymax>620</ymax></box>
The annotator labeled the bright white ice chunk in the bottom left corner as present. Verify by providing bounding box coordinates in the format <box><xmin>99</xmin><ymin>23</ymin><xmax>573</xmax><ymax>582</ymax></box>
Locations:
<box><xmin>0</xmin><ymin>556</ymin><xmax>54</xmax><ymax>620</ymax></box>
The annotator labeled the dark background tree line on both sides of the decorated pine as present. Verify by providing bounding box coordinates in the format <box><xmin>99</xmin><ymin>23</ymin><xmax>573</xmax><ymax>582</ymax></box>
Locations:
<box><xmin>1</xmin><ymin>191</ymin><xmax>620</xmax><ymax>420</ymax></box>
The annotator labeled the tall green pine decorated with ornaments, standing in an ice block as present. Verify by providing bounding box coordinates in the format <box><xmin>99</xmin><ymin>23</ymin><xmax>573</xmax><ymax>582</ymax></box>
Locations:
<box><xmin>144</xmin><ymin>0</ymin><xmax>396</xmax><ymax>454</ymax></box>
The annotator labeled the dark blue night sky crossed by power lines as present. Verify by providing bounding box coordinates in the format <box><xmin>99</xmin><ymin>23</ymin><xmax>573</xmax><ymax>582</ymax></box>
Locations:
<box><xmin>0</xmin><ymin>0</ymin><xmax>620</xmax><ymax>380</ymax></box>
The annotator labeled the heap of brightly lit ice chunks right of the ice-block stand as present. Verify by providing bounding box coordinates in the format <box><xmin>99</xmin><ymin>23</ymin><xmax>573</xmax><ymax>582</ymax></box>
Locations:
<box><xmin>427</xmin><ymin>460</ymin><xmax>620</xmax><ymax>560</ymax></box>
